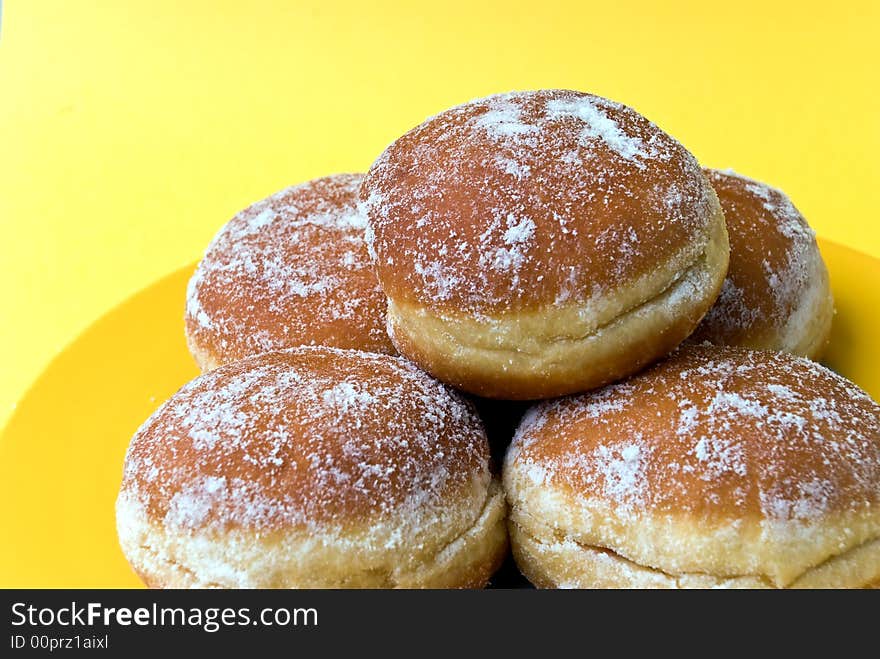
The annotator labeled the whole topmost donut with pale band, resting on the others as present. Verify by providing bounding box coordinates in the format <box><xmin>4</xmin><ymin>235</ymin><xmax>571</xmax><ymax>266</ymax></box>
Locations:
<box><xmin>361</xmin><ymin>90</ymin><xmax>728</xmax><ymax>400</ymax></box>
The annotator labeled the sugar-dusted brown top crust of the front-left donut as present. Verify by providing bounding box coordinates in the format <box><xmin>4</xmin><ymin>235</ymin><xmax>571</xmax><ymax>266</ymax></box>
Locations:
<box><xmin>122</xmin><ymin>347</ymin><xmax>491</xmax><ymax>532</ymax></box>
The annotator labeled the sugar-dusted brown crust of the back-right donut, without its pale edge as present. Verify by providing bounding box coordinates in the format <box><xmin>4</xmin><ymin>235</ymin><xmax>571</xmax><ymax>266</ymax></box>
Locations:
<box><xmin>694</xmin><ymin>170</ymin><xmax>822</xmax><ymax>345</ymax></box>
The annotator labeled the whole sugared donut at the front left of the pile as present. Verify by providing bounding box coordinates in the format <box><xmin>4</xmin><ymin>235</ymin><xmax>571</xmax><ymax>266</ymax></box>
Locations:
<box><xmin>116</xmin><ymin>346</ymin><xmax>507</xmax><ymax>588</ymax></box>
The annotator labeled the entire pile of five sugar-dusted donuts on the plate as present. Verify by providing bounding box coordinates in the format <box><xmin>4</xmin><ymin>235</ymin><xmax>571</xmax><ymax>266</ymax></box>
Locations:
<box><xmin>116</xmin><ymin>90</ymin><xmax>880</xmax><ymax>588</ymax></box>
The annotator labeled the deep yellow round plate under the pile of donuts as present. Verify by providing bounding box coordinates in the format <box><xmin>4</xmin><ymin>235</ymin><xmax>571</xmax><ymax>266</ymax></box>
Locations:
<box><xmin>0</xmin><ymin>241</ymin><xmax>880</xmax><ymax>588</ymax></box>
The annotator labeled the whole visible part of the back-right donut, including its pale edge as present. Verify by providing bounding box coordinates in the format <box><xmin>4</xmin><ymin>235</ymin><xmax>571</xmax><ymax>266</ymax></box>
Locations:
<box><xmin>691</xmin><ymin>169</ymin><xmax>834</xmax><ymax>359</ymax></box>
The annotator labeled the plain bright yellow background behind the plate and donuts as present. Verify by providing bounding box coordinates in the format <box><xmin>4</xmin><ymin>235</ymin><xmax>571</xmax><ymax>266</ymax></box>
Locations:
<box><xmin>0</xmin><ymin>0</ymin><xmax>880</xmax><ymax>424</ymax></box>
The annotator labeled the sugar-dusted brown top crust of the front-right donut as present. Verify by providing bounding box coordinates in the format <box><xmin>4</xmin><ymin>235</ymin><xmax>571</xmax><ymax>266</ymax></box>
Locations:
<box><xmin>507</xmin><ymin>345</ymin><xmax>880</xmax><ymax>523</ymax></box>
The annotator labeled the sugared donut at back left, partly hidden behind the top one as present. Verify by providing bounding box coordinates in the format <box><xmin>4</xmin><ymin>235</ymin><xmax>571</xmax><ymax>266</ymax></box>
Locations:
<box><xmin>185</xmin><ymin>174</ymin><xmax>395</xmax><ymax>371</ymax></box>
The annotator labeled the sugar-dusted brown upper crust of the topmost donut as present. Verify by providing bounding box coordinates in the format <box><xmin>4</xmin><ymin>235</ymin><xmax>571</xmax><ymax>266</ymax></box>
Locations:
<box><xmin>361</xmin><ymin>90</ymin><xmax>717</xmax><ymax>313</ymax></box>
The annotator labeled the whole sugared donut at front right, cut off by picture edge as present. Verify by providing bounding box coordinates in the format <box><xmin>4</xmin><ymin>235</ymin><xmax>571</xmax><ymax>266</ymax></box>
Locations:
<box><xmin>504</xmin><ymin>345</ymin><xmax>880</xmax><ymax>588</ymax></box>
